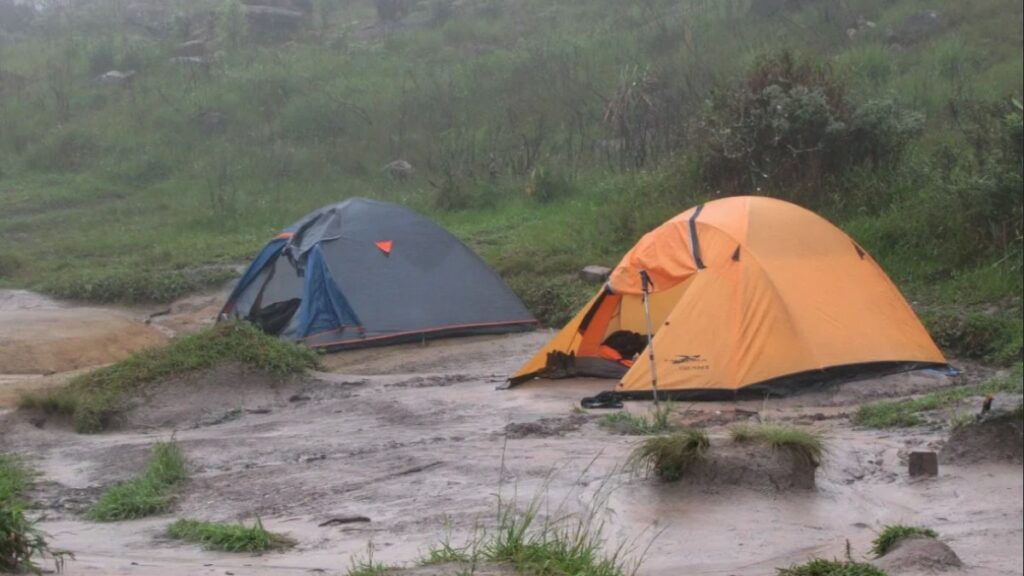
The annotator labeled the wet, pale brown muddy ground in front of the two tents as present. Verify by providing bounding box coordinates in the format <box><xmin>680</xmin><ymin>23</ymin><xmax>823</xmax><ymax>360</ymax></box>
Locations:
<box><xmin>0</xmin><ymin>291</ymin><xmax>1024</xmax><ymax>576</ymax></box>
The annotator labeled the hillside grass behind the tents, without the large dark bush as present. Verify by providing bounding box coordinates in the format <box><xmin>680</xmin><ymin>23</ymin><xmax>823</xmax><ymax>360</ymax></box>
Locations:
<box><xmin>0</xmin><ymin>0</ymin><xmax>1022</xmax><ymax>338</ymax></box>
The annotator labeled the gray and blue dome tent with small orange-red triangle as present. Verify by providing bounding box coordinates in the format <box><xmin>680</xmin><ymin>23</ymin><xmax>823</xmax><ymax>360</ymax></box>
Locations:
<box><xmin>221</xmin><ymin>198</ymin><xmax>537</xmax><ymax>349</ymax></box>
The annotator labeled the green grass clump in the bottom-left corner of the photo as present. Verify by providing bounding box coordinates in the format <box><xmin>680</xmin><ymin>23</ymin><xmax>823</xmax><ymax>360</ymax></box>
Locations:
<box><xmin>0</xmin><ymin>454</ymin><xmax>75</xmax><ymax>574</ymax></box>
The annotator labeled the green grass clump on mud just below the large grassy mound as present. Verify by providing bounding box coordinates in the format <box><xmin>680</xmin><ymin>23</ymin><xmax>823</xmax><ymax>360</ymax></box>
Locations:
<box><xmin>86</xmin><ymin>442</ymin><xmax>188</xmax><ymax>522</ymax></box>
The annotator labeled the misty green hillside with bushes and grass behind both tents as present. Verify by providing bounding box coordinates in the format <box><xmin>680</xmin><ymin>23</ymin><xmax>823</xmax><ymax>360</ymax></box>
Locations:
<box><xmin>0</xmin><ymin>0</ymin><xmax>1024</xmax><ymax>362</ymax></box>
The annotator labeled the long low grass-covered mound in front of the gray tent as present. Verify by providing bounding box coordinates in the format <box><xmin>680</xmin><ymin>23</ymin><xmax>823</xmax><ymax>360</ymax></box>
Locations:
<box><xmin>20</xmin><ymin>322</ymin><xmax>318</xmax><ymax>433</ymax></box>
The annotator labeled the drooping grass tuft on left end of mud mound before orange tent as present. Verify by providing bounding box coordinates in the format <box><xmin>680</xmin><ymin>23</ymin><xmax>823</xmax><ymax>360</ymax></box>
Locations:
<box><xmin>626</xmin><ymin>428</ymin><xmax>711</xmax><ymax>482</ymax></box>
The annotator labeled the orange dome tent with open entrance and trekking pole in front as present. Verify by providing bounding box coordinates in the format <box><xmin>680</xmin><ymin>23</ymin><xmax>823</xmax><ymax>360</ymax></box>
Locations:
<box><xmin>510</xmin><ymin>197</ymin><xmax>945</xmax><ymax>396</ymax></box>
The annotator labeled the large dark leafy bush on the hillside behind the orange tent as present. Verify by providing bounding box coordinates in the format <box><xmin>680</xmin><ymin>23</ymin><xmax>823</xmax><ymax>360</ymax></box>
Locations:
<box><xmin>699</xmin><ymin>51</ymin><xmax>923</xmax><ymax>206</ymax></box>
